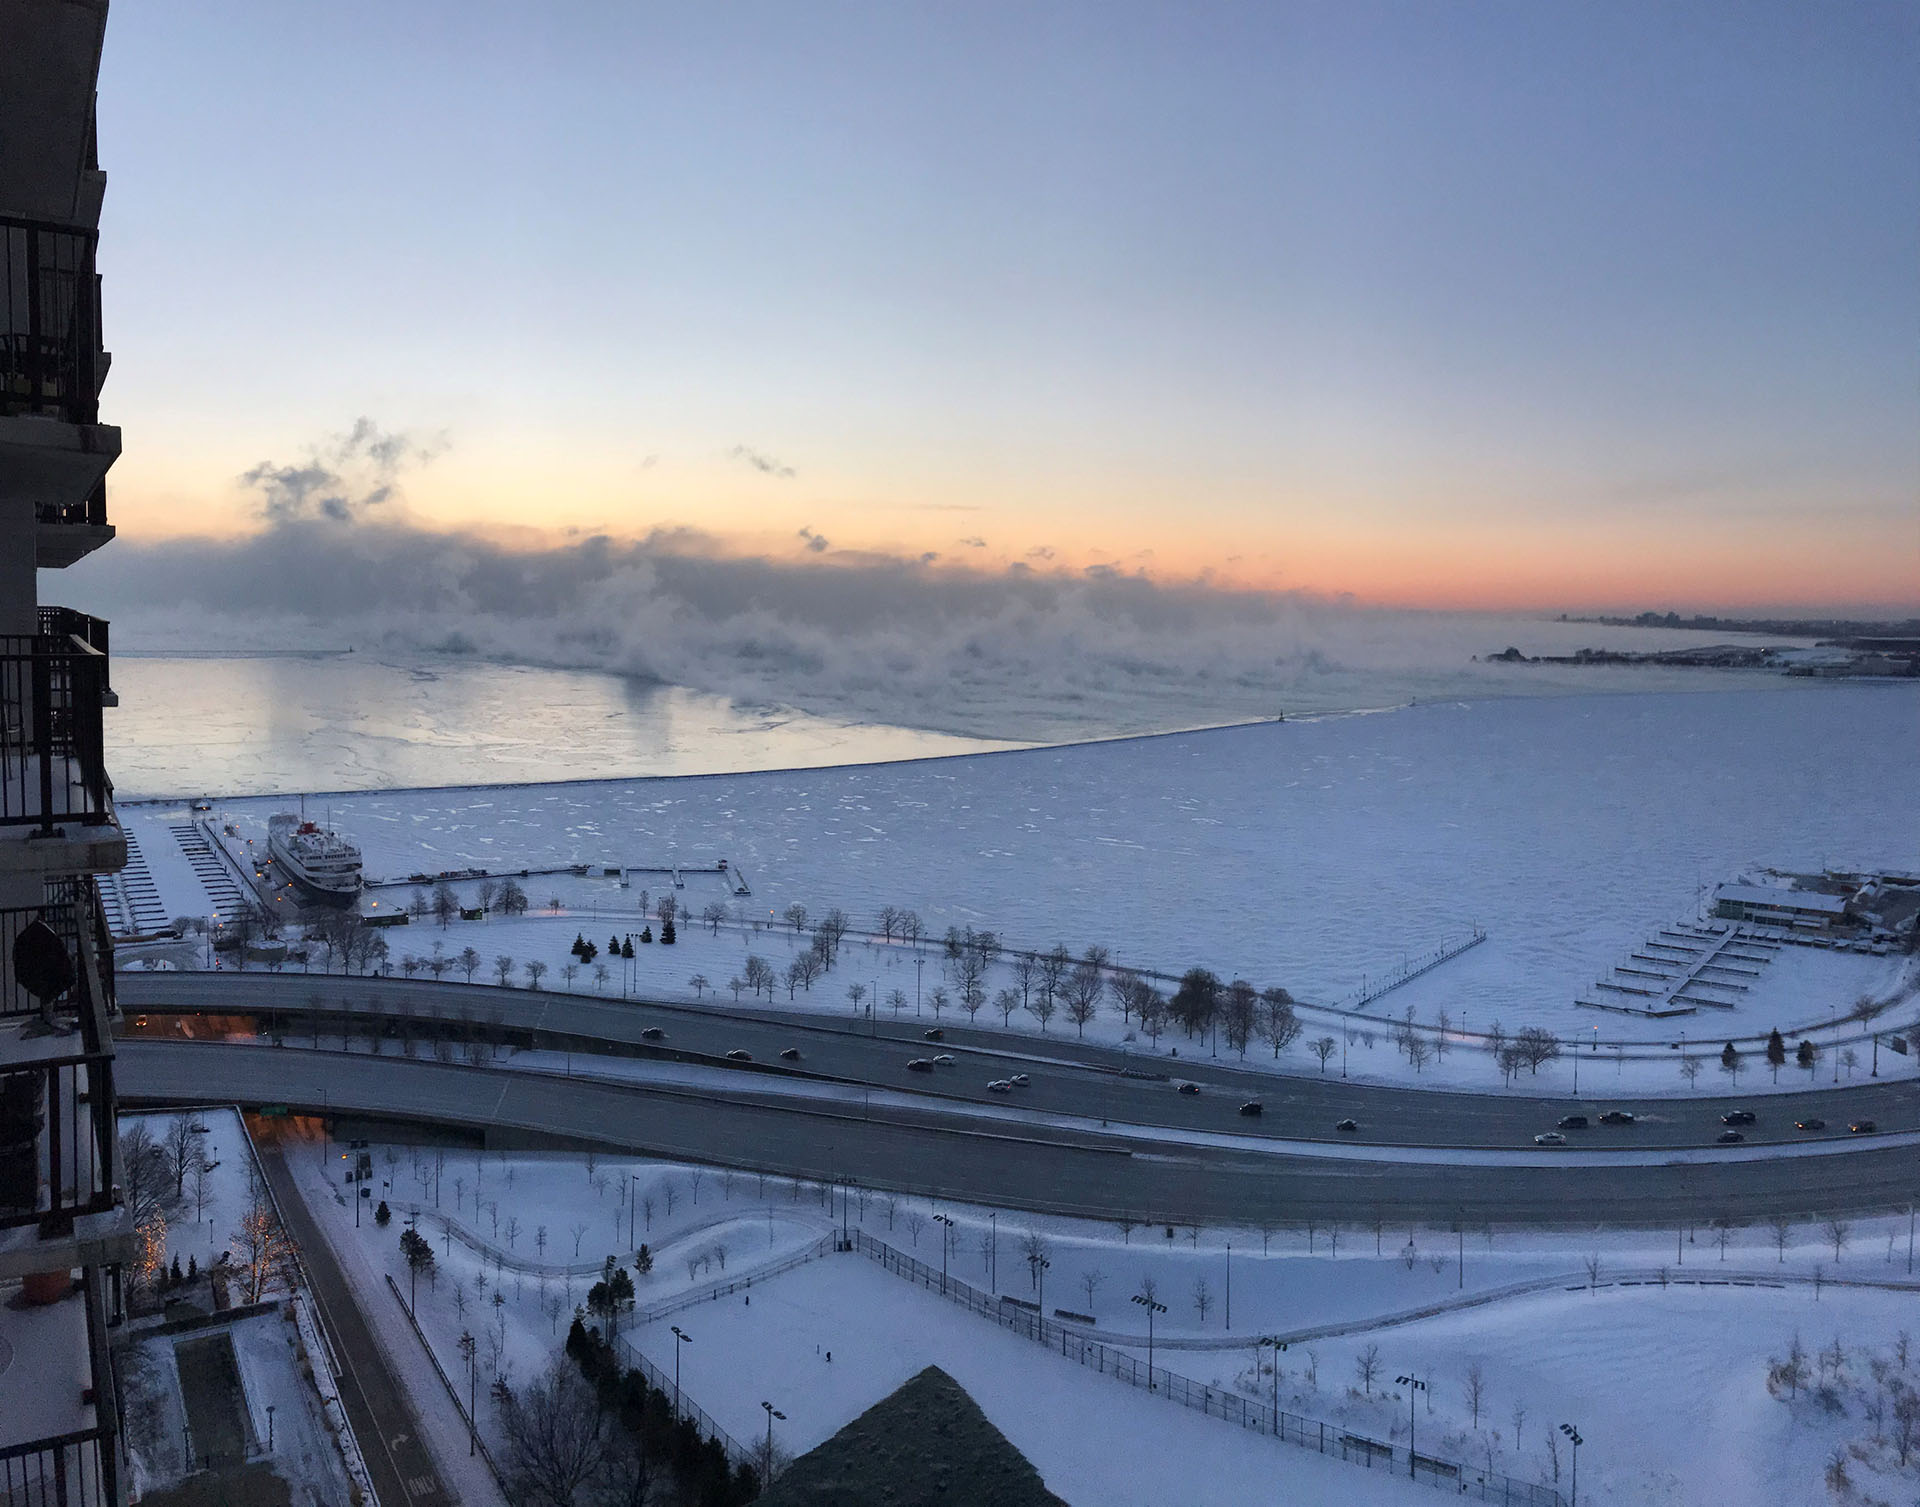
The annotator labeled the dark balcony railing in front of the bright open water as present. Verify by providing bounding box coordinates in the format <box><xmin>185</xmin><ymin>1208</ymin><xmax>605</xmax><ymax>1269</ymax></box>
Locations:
<box><xmin>0</xmin><ymin>629</ymin><xmax>113</xmax><ymax>837</ymax></box>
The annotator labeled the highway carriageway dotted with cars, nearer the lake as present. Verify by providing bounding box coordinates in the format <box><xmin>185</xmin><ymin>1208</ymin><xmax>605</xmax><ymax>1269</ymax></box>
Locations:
<box><xmin>117</xmin><ymin>973</ymin><xmax>1920</xmax><ymax>1160</ymax></box>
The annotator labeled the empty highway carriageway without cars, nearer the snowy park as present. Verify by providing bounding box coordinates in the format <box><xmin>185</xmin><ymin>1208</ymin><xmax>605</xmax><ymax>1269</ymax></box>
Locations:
<box><xmin>117</xmin><ymin>1039</ymin><xmax>1920</xmax><ymax>1227</ymax></box>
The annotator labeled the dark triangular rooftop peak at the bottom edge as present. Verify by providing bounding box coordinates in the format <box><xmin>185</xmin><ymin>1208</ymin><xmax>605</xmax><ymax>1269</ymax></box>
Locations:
<box><xmin>758</xmin><ymin>1365</ymin><xmax>1066</xmax><ymax>1507</ymax></box>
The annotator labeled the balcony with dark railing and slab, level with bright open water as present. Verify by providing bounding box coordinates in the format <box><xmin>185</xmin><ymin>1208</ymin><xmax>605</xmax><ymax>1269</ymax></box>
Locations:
<box><xmin>0</xmin><ymin>633</ymin><xmax>127</xmax><ymax>873</ymax></box>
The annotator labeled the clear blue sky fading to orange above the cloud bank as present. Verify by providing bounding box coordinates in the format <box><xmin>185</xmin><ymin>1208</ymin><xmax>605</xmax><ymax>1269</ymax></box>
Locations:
<box><xmin>86</xmin><ymin>0</ymin><xmax>1920</xmax><ymax>610</ymax></box>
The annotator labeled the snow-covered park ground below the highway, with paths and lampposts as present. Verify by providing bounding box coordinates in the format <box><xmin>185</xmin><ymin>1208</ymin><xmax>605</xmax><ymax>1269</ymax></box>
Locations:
<box><xmin>280</xmin><ymin>1142</ymin><xmax>1920</xmax><ymax>1507</ymax></box>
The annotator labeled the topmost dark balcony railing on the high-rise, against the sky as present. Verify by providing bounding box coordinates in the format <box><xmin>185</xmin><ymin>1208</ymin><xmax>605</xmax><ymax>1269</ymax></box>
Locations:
<box><xmin>0</xmin><ymin>217</ymin><xmax>102</xmax><ymax>424</ymax></box>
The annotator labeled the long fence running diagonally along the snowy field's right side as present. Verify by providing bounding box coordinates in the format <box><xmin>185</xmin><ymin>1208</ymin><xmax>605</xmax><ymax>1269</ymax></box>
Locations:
<box><xmin>852</xmin><ymin>1231</ymin><xmax>1565</xmax><ymax>1507</ymax></box>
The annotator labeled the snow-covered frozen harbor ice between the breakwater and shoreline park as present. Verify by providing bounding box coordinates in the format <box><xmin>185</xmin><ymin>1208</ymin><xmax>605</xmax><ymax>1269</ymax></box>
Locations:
<box><xmin>123</xmin><ymin>685</ymin><xmax>1920</xmax><ymax>1077</ymax></box>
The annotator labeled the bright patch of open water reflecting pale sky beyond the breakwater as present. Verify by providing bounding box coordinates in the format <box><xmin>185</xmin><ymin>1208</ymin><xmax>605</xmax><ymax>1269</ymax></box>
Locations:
<box><xmin>108</xmin><ymin>655</ymin><xmax>1014</xmax><ymax>799</ymax></box>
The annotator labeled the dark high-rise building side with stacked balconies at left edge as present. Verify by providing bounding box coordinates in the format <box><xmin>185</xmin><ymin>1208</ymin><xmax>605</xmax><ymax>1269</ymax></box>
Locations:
<box><xmin>0</xmin><ymin>0</ymin><xmax>134</xmax><ymax>1507</ymax></box>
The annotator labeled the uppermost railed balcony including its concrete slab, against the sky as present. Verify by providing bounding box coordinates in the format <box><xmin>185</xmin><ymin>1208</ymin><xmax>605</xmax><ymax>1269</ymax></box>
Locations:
<box><xmin>0</xmin><ymin>217</ymin><xmax>119</xmax><ymax>522</ymax></box>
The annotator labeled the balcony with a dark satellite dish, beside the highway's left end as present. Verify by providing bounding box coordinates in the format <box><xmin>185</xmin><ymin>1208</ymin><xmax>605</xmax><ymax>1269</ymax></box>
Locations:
<box><xmin>0</xmin><ymin>875</ymin><xmax>132</xmax><ymax>1277</ymax></box>
